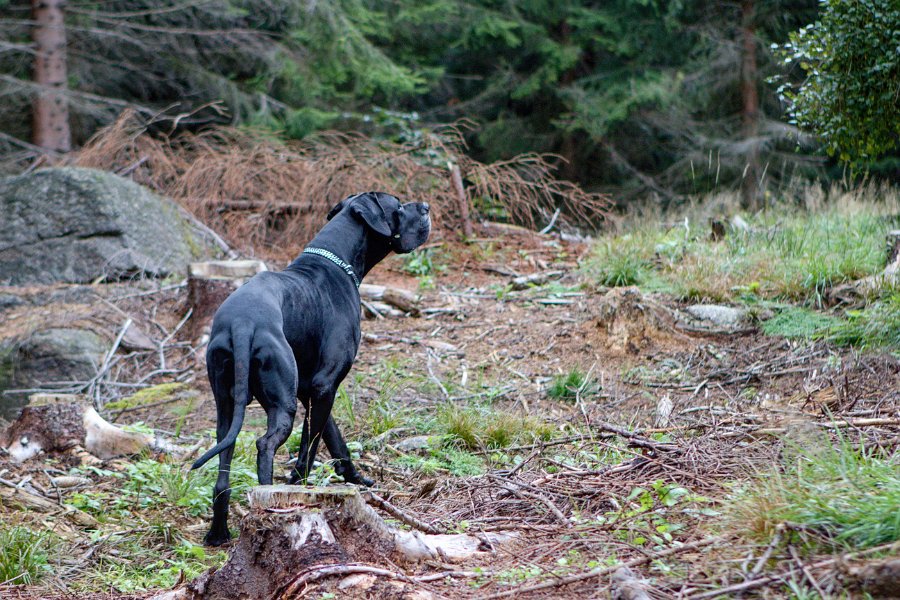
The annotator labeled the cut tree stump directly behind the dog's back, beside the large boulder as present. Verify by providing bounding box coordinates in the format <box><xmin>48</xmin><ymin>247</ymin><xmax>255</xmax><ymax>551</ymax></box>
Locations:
<box><xmin>185</xmin><ymin>260</ymin><xmax>268</xmax><ymax>339</ymax></box>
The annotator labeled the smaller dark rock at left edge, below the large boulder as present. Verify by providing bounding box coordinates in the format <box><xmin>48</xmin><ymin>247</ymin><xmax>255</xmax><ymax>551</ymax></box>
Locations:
<box><xmin>0</xmin><ymin>329</ymin><xmax>108</xmax><ymax>419</ymax></box>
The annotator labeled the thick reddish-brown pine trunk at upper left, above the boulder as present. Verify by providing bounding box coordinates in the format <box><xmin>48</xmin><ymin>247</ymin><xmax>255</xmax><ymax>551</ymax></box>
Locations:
<box><xmin>31</xmin><ymin>0</ymin><xmax>72</xmax><ymax>152</ymax></box>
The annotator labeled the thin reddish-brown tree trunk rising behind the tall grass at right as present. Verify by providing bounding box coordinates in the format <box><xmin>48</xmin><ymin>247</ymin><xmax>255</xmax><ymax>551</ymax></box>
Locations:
<box><xmin>741</xmin><ymin>0</ymin><xmax>761</xmax><ymax>210</ymax></box>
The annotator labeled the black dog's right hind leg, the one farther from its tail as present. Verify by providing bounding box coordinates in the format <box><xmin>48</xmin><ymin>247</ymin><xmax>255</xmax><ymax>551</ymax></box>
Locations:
<box><xmin>256</xmin><ymin>342</ymin><xmax>297</xmax><ymax>485</ymax></box>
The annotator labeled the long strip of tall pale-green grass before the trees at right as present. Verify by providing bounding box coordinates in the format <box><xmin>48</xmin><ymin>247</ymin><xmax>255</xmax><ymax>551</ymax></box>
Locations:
<box><xmin>585</xmin><ymin>202</ymin><xmax>892</xmax><ymax>303</ymax></box>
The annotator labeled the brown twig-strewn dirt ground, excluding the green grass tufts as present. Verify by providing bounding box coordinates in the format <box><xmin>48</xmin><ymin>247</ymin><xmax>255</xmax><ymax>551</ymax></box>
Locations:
<box><xmin>0</xmin><ymin>236</ymin><xmax>900</xmax><ymax>598</ymax></box>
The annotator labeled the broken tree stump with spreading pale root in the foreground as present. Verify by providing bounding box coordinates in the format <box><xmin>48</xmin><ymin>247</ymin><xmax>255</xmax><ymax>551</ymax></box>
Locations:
<box><xmin>153</xmin><ymin>485</ymin><xmax>511</xmax><ymax>600</ymax></box>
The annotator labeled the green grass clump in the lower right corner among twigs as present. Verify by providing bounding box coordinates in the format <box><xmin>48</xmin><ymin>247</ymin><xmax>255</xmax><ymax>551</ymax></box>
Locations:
<box><xmin>730</xmin><ymin>434</ymin><xmax>900</xmax><ymax>549</ymax></box>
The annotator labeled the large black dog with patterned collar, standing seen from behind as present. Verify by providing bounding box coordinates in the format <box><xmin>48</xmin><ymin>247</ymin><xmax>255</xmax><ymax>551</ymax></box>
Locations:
<box><xmin>192</xmin><ymin>192</ymin><xmax>431</xmax><ymax>546</ymax></box>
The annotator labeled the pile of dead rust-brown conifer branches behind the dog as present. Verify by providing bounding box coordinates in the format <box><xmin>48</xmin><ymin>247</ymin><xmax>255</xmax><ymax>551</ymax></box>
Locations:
<box><xmin>72</xmin><ymin>112</ymin><xmax>610</xmax><ymax>259</ymax></box>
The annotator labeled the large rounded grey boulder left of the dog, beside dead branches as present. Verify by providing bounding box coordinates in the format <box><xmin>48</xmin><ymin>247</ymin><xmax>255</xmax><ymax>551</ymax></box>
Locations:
<box><xmin>0</xmin><ymin>167</ymin><xmax>212</xmax><ymax>285</ymax></box>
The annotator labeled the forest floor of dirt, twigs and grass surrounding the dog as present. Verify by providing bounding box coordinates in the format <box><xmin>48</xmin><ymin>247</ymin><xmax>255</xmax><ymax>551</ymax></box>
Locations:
<box><xmin>0</xmin><ymin>209</ymin><xmax>900</xmax><ymax>598</ymax></box>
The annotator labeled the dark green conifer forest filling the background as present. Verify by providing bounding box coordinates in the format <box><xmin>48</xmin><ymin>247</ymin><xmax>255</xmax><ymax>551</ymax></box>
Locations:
<box><xmin>0</xmin><ymin>0</ymin><xmax>898</xmax><ymax>207</ymax></box>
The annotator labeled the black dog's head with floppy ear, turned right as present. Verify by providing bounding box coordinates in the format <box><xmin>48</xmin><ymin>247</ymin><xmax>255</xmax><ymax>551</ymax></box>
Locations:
<box><xmin>328</xmin><ymin>192</ymin><xmax>431</xmax><ymax>254</ymax></box>
